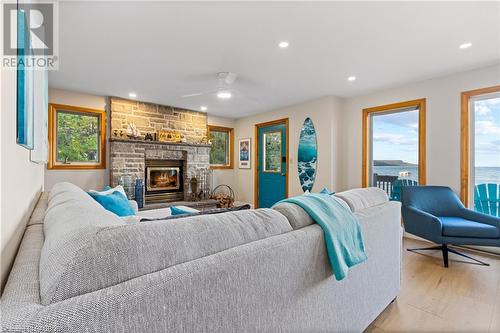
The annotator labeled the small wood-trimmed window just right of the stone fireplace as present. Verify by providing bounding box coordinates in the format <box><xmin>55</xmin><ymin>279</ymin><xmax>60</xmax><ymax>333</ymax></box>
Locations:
<box><xmin>208</xmin><ymin>125</ymin><xmax>234</xmax><ymax>169</ymax></box>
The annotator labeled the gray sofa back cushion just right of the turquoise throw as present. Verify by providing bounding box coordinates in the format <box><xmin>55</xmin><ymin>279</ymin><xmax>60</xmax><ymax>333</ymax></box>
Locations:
<box><xmin>335</xmin><ymin>187</ymin><xmax>389</xmax><ymax>212</ymax></box>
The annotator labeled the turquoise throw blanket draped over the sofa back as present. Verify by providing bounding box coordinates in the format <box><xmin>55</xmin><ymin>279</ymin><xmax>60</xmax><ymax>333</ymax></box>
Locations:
<box><xmin>278</xmin><ymin>193</ymin><xmax>366</xmax><ymax>280</ymax></box>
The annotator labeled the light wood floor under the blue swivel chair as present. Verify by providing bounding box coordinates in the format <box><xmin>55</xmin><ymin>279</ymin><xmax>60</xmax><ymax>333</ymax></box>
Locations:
<box><xmin>365</xmin><ymin>238</ymin><xmax>500</xmax><ymax>333</ymax></box>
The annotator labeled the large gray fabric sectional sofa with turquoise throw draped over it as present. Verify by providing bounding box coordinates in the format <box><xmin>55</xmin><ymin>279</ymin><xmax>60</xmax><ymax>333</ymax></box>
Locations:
<box><xmin>1</xmin><ymin>183</ymin><xmax>401</xmax><ymax>332</ymax></box>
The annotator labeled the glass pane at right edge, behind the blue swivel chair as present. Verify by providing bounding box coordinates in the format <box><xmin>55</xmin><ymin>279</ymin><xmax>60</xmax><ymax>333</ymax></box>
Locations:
<box><xmin>473</xmin><ymin>95</ymin><xmax>500</xmax><ymax>216</ymax></box>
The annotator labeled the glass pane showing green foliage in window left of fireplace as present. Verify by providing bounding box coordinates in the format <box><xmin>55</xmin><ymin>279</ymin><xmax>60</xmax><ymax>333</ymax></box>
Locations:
<box><xmin>56</xmin><ymin>111</ymin><xmax>100</xmax><ymax>163</ymax></box>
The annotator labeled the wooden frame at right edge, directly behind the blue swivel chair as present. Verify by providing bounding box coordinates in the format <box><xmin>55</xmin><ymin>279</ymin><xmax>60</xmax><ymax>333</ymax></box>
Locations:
<box><xmin>460</xmin><ymin>85</ymin><xmax>500</xmax><ymax>208</ymax></box>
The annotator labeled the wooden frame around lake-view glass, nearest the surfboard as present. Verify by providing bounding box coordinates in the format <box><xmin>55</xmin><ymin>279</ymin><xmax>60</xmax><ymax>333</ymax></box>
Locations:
<box><xmin>361</xmin><ymin>98</ymin><xmax>426</xmax><ymax>187</ymax></box>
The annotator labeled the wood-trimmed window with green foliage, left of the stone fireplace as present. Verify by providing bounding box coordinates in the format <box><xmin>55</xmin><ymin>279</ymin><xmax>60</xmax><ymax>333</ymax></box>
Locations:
<box><xmin>48</xmin><ymin>104</ymin><xmax>106</xmax><ymax>169</ymax></box>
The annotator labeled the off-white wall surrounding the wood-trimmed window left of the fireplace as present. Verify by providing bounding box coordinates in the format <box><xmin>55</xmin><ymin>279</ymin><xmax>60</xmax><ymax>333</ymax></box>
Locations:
<box><xmin>45</xmin><ymin>88</ymin><xmax>110</xmax><ymax>191</ymax></box>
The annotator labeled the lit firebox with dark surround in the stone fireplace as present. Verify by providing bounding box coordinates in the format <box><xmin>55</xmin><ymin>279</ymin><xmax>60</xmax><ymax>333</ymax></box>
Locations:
<box><xmin>144</xmin><ymin>160</ymin><xmax>184</xmax><ymax>204</ymax></box>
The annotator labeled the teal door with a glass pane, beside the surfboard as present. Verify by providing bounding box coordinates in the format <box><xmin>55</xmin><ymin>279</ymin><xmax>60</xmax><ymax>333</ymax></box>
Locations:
<box><xmin>257</xmin><ymin>123</ymin><xmax>287</xmax><ymax>208</ymax></box>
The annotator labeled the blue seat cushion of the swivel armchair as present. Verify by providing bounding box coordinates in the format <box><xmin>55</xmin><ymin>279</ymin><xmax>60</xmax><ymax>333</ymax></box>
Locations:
<box><xmin>439</xmin><ymin>217</ymin><xmax>500</xmax><ymax>238</ymax></box>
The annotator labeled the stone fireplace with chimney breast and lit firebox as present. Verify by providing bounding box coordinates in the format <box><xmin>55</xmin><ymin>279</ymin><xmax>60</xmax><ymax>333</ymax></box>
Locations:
<box><xmin>109</xmin><ymin>97</ymin><xmax>210</xmax><ymax>205</ymax></box>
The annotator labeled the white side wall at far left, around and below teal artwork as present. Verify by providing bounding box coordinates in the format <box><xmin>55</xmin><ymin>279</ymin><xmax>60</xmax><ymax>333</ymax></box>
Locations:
<box><xmin>0</xmin><ymin>70</ymin><xmax>44</xmax><ymax>287</ymax></box>
